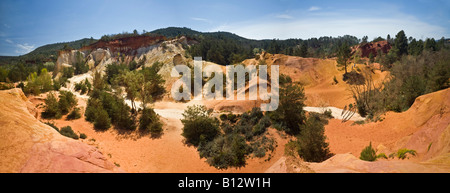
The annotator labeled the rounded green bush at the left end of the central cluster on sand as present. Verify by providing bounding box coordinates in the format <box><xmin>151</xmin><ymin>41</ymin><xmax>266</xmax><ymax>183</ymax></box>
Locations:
<box><xmin>181</xmin><ymin>105</ymin><xmax>219</xmax><ymax>146</ymax></box>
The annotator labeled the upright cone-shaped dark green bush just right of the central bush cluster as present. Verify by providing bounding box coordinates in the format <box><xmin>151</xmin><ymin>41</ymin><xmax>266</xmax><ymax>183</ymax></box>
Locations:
<box><xmin>297</xmin><ymin>115</ymin><xmax>333</xmax><ymax>162</ymax></box>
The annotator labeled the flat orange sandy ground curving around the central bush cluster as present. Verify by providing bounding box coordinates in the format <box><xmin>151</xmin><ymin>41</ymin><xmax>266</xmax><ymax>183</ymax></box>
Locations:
<box><xmin>29</xmin><ymin>91</ymin><xmax>288</xmax><ymax>173</ymax></box>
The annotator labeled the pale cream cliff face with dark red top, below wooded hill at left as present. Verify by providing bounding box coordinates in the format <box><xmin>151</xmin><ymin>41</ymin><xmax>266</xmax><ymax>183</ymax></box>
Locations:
<box><xmin>54</xmin><ymin>36</ymin><xmax>193</xmax><ymax>99</ymax></box>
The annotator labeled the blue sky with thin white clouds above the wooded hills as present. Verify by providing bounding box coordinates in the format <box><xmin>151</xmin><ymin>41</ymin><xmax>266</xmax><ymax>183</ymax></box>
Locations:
<box><xmin>0</xmin><ymin>0</ymin><xmax>450</xmax><ymax>56</ymax></box>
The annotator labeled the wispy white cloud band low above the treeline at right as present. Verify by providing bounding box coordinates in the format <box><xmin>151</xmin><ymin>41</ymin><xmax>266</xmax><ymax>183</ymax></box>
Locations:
<box><xmin>212</xmin><ymin>9</ymin><xmax>450</xmax><ymax>39</ymax></box>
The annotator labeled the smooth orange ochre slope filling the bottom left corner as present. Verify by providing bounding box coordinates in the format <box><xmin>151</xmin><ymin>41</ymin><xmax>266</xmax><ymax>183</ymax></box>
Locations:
<box><xmin>0</xmin><ymin>89</ymin><xmax>122</xmax><ymax>173</ymax></box>
